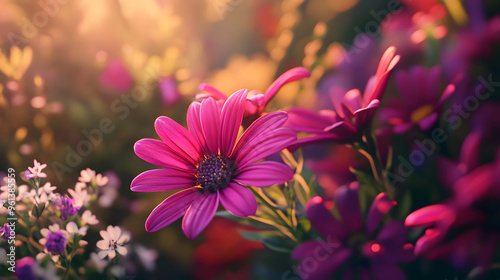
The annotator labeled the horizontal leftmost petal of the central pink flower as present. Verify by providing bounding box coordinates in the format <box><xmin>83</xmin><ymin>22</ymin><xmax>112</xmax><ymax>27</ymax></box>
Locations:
<box><xmin>130</xmin><ymin>169</ymin><xmax>196</xmax><ymax>192</ymax></box>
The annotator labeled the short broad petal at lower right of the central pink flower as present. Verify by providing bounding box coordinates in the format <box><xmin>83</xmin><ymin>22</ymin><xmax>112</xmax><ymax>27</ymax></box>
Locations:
<box><xmin>219</xmin><ymin>183</ymin><xmax>257</xmax><ymax>217</ymax></box>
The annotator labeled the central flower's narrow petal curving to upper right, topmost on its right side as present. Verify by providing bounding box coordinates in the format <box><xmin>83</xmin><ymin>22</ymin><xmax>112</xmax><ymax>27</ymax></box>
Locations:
<box><xmin>233</xmin><ymin>112</ymin><xmax>288</xmax><ymax>154</ymax></box>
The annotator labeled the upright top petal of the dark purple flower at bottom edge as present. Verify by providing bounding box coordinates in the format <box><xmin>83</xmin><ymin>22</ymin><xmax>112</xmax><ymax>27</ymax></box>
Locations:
<box><xmin>335</xmin><ymin>182</ymin><xmax>363</xmax><ymax>231</ymax></box>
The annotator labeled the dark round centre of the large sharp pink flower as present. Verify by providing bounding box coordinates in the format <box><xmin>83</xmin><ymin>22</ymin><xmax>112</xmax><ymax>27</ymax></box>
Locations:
<box><xmin>196</xmin><ymin>155</ymin><xmax>234</xmax><ymax>192</ymax></box>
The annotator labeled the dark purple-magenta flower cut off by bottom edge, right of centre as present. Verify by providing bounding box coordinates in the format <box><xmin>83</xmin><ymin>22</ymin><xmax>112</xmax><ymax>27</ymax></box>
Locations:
<box><xmin>292</xmin><ymin>183</ymin><xmax>414</xmax><ymax>280</ymax></box>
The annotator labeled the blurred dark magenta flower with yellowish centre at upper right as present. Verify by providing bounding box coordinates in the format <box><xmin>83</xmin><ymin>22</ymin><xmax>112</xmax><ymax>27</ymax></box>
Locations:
<box><xmin>380</xmin><ymin>66</ymin><xmax>455</xmax><ymax>133</ymax></box>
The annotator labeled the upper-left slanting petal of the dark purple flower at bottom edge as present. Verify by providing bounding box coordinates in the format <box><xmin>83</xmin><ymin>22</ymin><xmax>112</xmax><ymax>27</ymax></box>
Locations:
<box><xmin>306</xmin><ymin>196</ymin><xmax>349</xmax><ymax>241</ymax></box>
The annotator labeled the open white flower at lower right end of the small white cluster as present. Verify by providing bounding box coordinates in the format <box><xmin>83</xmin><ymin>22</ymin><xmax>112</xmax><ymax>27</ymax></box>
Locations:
<box><xmin>96</xmin><ymin>225</ymin><xmax>130</xmax><ymax>259</ymax></box>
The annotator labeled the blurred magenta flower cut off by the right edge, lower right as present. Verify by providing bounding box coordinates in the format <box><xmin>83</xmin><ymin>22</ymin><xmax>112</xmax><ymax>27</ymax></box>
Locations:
<box><xmin>405</xmin><ymin>154</ymin><xmax>500</xmax><ymax>271</ymax></box>
